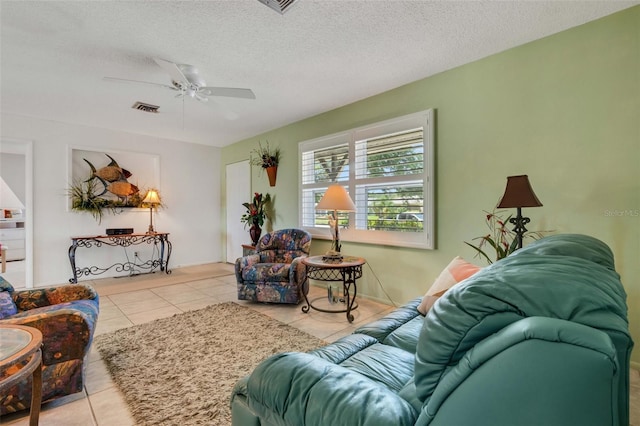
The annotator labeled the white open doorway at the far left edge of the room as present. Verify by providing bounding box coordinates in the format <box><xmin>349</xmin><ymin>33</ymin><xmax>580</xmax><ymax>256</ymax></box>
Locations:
<box><xmin>0</xmin><ymin>139</ymin><xmax>33</xmax><ymax>288</ymax></box>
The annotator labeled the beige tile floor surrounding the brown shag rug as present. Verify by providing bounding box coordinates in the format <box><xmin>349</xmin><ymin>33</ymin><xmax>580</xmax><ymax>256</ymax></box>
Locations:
<box><xmin>0</xmin><ymin>263</ymin><xmax>640</xmax><ymax>426</ymax></box>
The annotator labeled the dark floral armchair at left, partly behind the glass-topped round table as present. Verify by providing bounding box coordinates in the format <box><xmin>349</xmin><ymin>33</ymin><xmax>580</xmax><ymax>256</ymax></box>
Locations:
<box><xmin>0</xmin><ymin>277</ymin><xmax>99</xmax><ymax>415</ymax></box>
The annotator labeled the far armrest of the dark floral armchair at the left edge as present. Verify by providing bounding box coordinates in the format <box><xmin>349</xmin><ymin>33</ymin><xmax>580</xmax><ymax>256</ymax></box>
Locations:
<box><xmin>13</xmin><ymin>284</ymin><xmax>98</xmax><ymax>311</ymax></box>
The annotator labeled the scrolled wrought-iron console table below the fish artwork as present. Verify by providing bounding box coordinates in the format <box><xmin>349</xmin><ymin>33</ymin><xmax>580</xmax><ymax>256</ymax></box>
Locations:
<box><xmin>69</xmin><ymin>232</ymin><xmax>171</xmax><ymax>283</ymax></box>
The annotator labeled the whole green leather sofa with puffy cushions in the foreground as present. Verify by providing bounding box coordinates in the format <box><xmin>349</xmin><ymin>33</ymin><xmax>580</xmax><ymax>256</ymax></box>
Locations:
<box><xmin>231</xmin><ymin>235</ymin><xmax>633</xmax><ymax>426</ymax></box>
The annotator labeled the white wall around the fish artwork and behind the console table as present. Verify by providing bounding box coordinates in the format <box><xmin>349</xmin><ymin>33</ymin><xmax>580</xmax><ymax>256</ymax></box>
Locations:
<box><xmin>0</xmin><ymin>114</ymin><xmax>222</xmax><ymax>287</ymax></box>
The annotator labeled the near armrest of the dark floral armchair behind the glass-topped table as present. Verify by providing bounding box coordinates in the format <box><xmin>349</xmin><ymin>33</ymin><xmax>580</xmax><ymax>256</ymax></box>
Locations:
<box><xmin>0</xmin><ymin>300</ymin><xmax>99</xmax><ymax>365</ymax></box>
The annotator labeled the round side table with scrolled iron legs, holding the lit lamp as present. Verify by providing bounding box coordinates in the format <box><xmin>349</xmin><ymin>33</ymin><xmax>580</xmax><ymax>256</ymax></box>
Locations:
<box><xmin>302</xmin><ymin>256</ymin><xmax>367</xmax><ymax>322</ymax></box>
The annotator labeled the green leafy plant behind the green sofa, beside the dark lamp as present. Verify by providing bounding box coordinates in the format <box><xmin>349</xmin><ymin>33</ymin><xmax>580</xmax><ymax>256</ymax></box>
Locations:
<box><xmin>464</xmin><ymin>210</ymin><xmax>544</xmax><ymax>264</ymax></box>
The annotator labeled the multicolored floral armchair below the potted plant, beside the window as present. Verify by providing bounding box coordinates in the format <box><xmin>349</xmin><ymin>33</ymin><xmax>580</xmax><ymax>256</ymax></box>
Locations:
<box><xmin>235</xmin><ymin>229</ymin><xmax>311</xmax><ymax>304</ymax></box>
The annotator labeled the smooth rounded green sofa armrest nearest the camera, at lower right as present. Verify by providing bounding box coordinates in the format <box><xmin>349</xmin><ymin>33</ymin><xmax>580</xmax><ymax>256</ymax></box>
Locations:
<box><xmin>416</xmin><ymin>317</ymin><xmax>620</xmax><ymax>425</ymax></box>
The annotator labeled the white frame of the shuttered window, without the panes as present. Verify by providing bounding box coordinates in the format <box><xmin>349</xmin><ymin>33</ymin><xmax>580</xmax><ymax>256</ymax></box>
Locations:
<box><xmin>298</xmin><ymin>109</ymin><xmax>435</xmax><ymax>250</ymax></box>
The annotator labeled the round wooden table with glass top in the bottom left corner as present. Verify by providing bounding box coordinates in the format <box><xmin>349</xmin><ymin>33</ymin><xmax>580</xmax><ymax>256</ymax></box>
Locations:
<box><xmin>0</xmin><ymin>324</ymin><xmax>42</xmax><ymax>426</ymax></box>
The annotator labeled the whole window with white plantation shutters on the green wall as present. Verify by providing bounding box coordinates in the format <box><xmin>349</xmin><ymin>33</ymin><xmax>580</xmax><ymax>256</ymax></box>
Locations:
<box><xmin>299</xmin><ymin>110</ymin><xmax>435</xmax><ymax>249</ymax></box>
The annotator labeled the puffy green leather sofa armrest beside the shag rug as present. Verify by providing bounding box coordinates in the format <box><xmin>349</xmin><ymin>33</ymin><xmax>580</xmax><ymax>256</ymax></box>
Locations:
<box><xmin>246</xmin><ymin>353</ymin><xmax>417</xmax><ymax>426</ymax></box>
